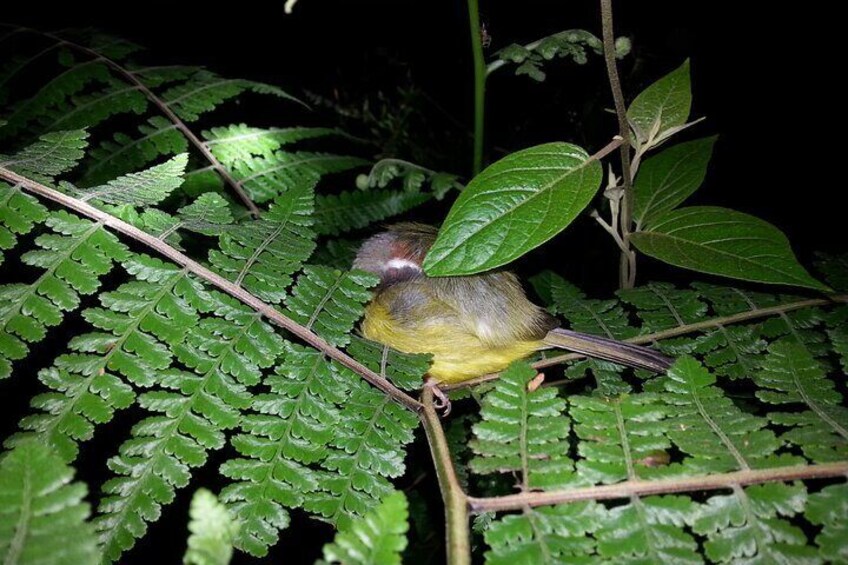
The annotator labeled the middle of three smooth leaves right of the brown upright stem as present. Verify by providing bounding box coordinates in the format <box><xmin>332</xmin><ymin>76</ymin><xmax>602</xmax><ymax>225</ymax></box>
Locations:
<box><xmin>633</xmin><ymin>136</ymin><xmax>716</xmax><ymax>227</ymax></box>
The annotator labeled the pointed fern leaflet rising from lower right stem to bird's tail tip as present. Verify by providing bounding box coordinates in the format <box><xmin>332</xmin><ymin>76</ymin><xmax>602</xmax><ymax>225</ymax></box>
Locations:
<box><xmin>658</xmin><ymin>357</ymin><xmax>795</xmax><ymax>472</ymax></box>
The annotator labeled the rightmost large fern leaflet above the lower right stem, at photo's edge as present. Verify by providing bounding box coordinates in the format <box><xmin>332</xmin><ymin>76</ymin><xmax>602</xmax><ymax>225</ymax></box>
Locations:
<box><xmin>754</xmin><ymin>338</ymin><xmax>848</xmax><ymax>463</ymax></box>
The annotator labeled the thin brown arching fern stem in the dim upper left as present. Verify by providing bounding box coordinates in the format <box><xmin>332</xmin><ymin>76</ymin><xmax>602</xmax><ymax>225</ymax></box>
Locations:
<box><xmin>21</xmin><ymin>28</ymin><xmax>261</xmax><ymax>218</ymax></box>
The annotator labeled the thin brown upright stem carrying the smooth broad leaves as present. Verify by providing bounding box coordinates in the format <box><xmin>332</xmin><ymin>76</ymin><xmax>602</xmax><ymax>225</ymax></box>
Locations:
<box><xmin>601</xmin><ymin>0</ymin><xmax>636</xmax><ymax>288</ymax></box>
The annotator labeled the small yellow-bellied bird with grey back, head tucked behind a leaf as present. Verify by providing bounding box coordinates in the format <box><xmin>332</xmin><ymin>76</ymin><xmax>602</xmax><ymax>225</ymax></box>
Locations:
<box><xmin>353</xmin><ymin>223</ymin><xmax>671</xmax><ymax>400</ymax></box>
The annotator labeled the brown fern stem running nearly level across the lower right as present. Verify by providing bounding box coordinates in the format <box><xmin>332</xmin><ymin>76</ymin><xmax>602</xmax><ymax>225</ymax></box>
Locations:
<box><xmin>468</xmin><ymin>461</ymin><xmax>848</xmax><ymax>514</ymax></box>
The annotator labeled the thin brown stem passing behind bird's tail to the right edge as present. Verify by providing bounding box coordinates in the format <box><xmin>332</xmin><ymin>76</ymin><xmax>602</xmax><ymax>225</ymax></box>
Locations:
<box><xmin>439</xmin><ymin>294</ymin><xmax>848</xmax><ymax>391</ymax></box>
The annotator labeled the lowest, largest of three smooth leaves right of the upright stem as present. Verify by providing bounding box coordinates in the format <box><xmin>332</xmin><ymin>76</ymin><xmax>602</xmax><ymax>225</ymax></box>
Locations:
<box><xmin>630</xmin><ymin>206</ymin><xmax>828</xmax><ymax>291</ymax></box>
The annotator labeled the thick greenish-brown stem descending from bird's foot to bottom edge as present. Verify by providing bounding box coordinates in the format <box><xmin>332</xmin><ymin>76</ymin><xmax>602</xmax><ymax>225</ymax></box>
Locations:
<box><xmin>419</xmin><ymin>387</ymin><xmax>471</xmax><ymax>565</ymax></box>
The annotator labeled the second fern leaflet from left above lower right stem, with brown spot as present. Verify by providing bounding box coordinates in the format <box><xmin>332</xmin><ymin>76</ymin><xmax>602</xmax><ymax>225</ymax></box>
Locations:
<box><xmin>569</xmin><ymin>393</ymin><xmax>671</xmax><ymax>484</ymax></box>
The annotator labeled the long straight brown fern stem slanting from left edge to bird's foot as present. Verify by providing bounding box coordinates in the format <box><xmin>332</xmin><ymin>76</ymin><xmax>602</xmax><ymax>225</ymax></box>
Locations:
<box><xmin>0</xmin><ymin>167</ymin><xmax>422</xmax><ymax>412</ymax></box>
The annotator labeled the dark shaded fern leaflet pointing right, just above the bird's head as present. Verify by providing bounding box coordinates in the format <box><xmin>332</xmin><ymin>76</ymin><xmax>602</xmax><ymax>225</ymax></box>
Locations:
<box><xmin>315</xmin><ymin>190</ymin><xmax>432</xmax><ymax>235</ymax></box>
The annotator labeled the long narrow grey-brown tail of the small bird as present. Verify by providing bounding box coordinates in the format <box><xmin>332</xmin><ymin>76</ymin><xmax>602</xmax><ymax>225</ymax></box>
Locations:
<box><xmin>542</xmin><ymin>328</ymin><xmax>673</xmax><ymax>373</ymax></box>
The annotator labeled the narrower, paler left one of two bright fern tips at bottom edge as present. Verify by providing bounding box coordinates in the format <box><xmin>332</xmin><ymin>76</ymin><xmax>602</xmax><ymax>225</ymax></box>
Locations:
<box><xmin>183</xmin><ymin>488</ymin><xmax>239</xmax><ymax>565</ymax></box>
